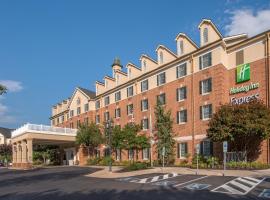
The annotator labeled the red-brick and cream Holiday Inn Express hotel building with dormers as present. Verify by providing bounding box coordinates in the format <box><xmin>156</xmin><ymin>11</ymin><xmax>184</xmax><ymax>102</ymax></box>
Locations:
<box><xmin>50</xmin><ymin>19</ymin><xmax>270</xmax><ymax>166</ymax></box>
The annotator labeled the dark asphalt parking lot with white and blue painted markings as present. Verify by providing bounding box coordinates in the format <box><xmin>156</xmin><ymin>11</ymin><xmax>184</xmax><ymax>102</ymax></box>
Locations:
<box><xmin>0</xmin><ymin>167</ymin><xmax>270</xmax><ymax>200</ymax></box>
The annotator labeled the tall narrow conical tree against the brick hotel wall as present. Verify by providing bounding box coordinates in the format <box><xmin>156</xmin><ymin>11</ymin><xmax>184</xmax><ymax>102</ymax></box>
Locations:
<box><xmin>155</xmin><ymin>101</ymin><xmax>175</xmax><ymax>164</ymax></box>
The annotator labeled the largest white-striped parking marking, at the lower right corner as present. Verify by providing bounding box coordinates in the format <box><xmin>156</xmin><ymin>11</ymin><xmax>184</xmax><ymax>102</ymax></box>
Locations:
<box><xmin>211</xmin><ymin>177</ymin><xmax>265</xmax><ymax>195</ymax></box>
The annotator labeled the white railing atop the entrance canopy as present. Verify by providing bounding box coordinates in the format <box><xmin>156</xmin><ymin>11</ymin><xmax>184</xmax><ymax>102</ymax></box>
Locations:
<box><xmin>11</xmin><ymin>124</ymin><xmax>77</xmax><ymax>138</ymax></box>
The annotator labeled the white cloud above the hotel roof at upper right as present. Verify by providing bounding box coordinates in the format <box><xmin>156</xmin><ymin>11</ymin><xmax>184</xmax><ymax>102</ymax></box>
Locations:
<box><xmin>225</xmin><ymin>9</ymin><xmax>270</xmax><ymax>36</ymax></box>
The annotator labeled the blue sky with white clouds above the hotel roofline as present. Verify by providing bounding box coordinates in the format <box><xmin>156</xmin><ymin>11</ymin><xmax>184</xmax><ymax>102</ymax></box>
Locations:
<box><xmin>0</xmin><ymin>0</ymin><xmax>270</xmax><ymax>128</ymax></box>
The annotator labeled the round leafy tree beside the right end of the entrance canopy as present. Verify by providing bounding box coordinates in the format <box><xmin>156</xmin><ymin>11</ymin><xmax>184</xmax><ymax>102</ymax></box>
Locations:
<box><xmin>76</xmin><ymin>122</ymin><xmax>104</xmax><ymax>158</ymax></box>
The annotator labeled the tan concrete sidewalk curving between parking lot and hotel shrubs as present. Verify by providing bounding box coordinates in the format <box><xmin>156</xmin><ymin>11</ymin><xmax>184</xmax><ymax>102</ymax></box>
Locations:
<box><xmin>87</xmin><ymin>166</ymin><xmax>270</xmax><ymax>178</ymax></box>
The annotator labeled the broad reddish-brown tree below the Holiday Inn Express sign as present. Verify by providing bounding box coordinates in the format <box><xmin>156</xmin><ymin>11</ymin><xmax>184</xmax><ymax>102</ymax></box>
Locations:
<box><xmin>207</xmin><ymin>101</ymin><xmax>270</xmax><ymax>160</ymax></box>
